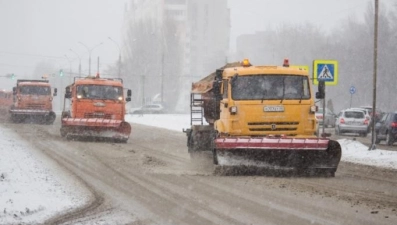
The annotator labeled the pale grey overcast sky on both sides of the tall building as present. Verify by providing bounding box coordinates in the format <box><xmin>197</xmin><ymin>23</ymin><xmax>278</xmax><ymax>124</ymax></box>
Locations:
<box><xmin>0</xmin><ymin>0</ymin><xmax>393</xmax><ymax>88</ymax></box>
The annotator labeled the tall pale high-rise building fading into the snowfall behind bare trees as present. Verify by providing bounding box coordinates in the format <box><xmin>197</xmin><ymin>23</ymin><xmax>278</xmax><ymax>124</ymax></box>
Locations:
<box><xmin>123</xmin><ymin>0</ymin><xmax>230</xmax><ymax>111</ymax></box>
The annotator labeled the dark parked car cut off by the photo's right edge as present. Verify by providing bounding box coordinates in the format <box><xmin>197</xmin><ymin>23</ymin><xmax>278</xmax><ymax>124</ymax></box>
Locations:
<box><xmin>375</xmin><ymin>112</ymin><xmax>397</xmax><ymax>145</ymax></box>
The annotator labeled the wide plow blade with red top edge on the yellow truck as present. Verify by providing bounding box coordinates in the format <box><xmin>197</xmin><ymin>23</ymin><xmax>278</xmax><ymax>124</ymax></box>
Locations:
<box><xmin>214</xmin><ymin>137</ymin><xmax>342</xmax><ymax>176</ymax></box>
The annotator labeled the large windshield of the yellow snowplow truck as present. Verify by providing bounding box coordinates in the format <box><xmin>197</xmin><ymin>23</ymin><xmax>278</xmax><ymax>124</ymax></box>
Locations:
<box><xmin>232</xmin><ymin>75</ymin><xmax>310</xmax><ymax>100</ymax></box>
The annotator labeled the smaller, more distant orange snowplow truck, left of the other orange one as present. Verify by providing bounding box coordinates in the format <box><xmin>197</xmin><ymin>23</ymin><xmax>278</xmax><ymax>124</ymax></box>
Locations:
<box><xmin>9</xmin><ymin>80</ymin><xmax>57</xmax><ymax>124</ymax></box>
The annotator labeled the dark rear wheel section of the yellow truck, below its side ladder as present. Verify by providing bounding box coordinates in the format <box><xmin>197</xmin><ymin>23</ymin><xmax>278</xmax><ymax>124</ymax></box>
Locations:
<box><xmin>185</xmin><ymin>125</ymin><xmax>215</xmax><ymax>159</ymax></box>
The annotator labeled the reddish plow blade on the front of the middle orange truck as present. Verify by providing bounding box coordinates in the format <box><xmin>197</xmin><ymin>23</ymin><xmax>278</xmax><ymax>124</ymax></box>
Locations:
<box><xmin>61</xmin><ymin>118</ymin><xmax>131</xmax><ymax>142</ymax></box>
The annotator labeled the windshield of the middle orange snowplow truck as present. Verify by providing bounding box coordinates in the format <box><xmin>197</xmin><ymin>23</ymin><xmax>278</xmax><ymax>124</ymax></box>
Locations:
<box><xmin>77</xmin><ymin>85</ymin><xmax>123</xmax><ymax>100</ymax></box>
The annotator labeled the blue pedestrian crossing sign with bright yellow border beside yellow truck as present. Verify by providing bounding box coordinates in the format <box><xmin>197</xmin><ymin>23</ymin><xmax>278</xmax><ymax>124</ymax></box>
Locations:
<box><xmin>313</xmin><ymin>60</ymin><xmax>338</xmax><ymax>85</ymax></box>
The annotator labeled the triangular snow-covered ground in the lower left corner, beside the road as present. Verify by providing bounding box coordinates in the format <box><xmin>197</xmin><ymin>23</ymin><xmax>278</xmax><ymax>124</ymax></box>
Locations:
<box><xmin>0</xmin><ymin>126</ymin><xmax>91</xmax><ymax>224</ymax></box>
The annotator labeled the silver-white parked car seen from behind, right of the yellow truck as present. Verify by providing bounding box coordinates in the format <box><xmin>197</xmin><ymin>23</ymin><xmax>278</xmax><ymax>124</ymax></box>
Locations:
<box><xmin>335</xmin><ymin>108</ymin><xmax>369</xmax><ymax>137</ymax></box>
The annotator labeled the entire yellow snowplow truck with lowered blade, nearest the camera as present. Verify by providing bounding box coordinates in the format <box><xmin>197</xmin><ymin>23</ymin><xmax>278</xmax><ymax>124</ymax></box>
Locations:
<box><xmin>184</xmin><ymin>59</ymin><xmax>341</xmax><ymax>176</ymax></box>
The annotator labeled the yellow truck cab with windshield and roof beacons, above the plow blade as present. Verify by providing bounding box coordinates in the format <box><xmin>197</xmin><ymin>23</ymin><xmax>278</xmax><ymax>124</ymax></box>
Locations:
<box><xmin>215</xmin><ymin>60</ymin><xmax>316</xmax><ymax>137</ymax></box>
